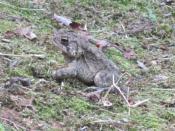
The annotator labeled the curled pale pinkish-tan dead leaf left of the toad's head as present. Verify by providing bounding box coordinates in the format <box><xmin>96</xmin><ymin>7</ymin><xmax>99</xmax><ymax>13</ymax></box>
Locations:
<box><xmin>15</xmin><ymin>26</ymin><xmax>37</xmax><ymax>40</ymax></box>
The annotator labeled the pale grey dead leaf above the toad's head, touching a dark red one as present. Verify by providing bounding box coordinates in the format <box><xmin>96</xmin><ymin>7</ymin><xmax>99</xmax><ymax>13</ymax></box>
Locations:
<box><xmin>53</xmin><ymin>14</ymin><xmax>72</xmax><ymax>26</ymax></box>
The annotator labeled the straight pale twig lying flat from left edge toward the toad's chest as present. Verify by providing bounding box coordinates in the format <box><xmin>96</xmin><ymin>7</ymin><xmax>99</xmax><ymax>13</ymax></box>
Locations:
<box><xmin>0</xmin><ymin>52</ymin><xmax>46</xmax><ymax>58</ymax></box>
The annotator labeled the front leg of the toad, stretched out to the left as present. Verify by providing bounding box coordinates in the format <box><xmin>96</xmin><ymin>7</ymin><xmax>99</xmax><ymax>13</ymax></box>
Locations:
<box><xmin>52</xmin><ymin>62</ymin><xmax>77</xmax><ymax>81</ymax></box>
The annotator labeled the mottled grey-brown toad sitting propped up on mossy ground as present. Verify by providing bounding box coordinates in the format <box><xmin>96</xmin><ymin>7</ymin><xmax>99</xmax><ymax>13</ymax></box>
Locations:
<box><xmin>53</xmin><ymin>30</ymin><xmax>120</xmax><ymax>87</ymax></box>
